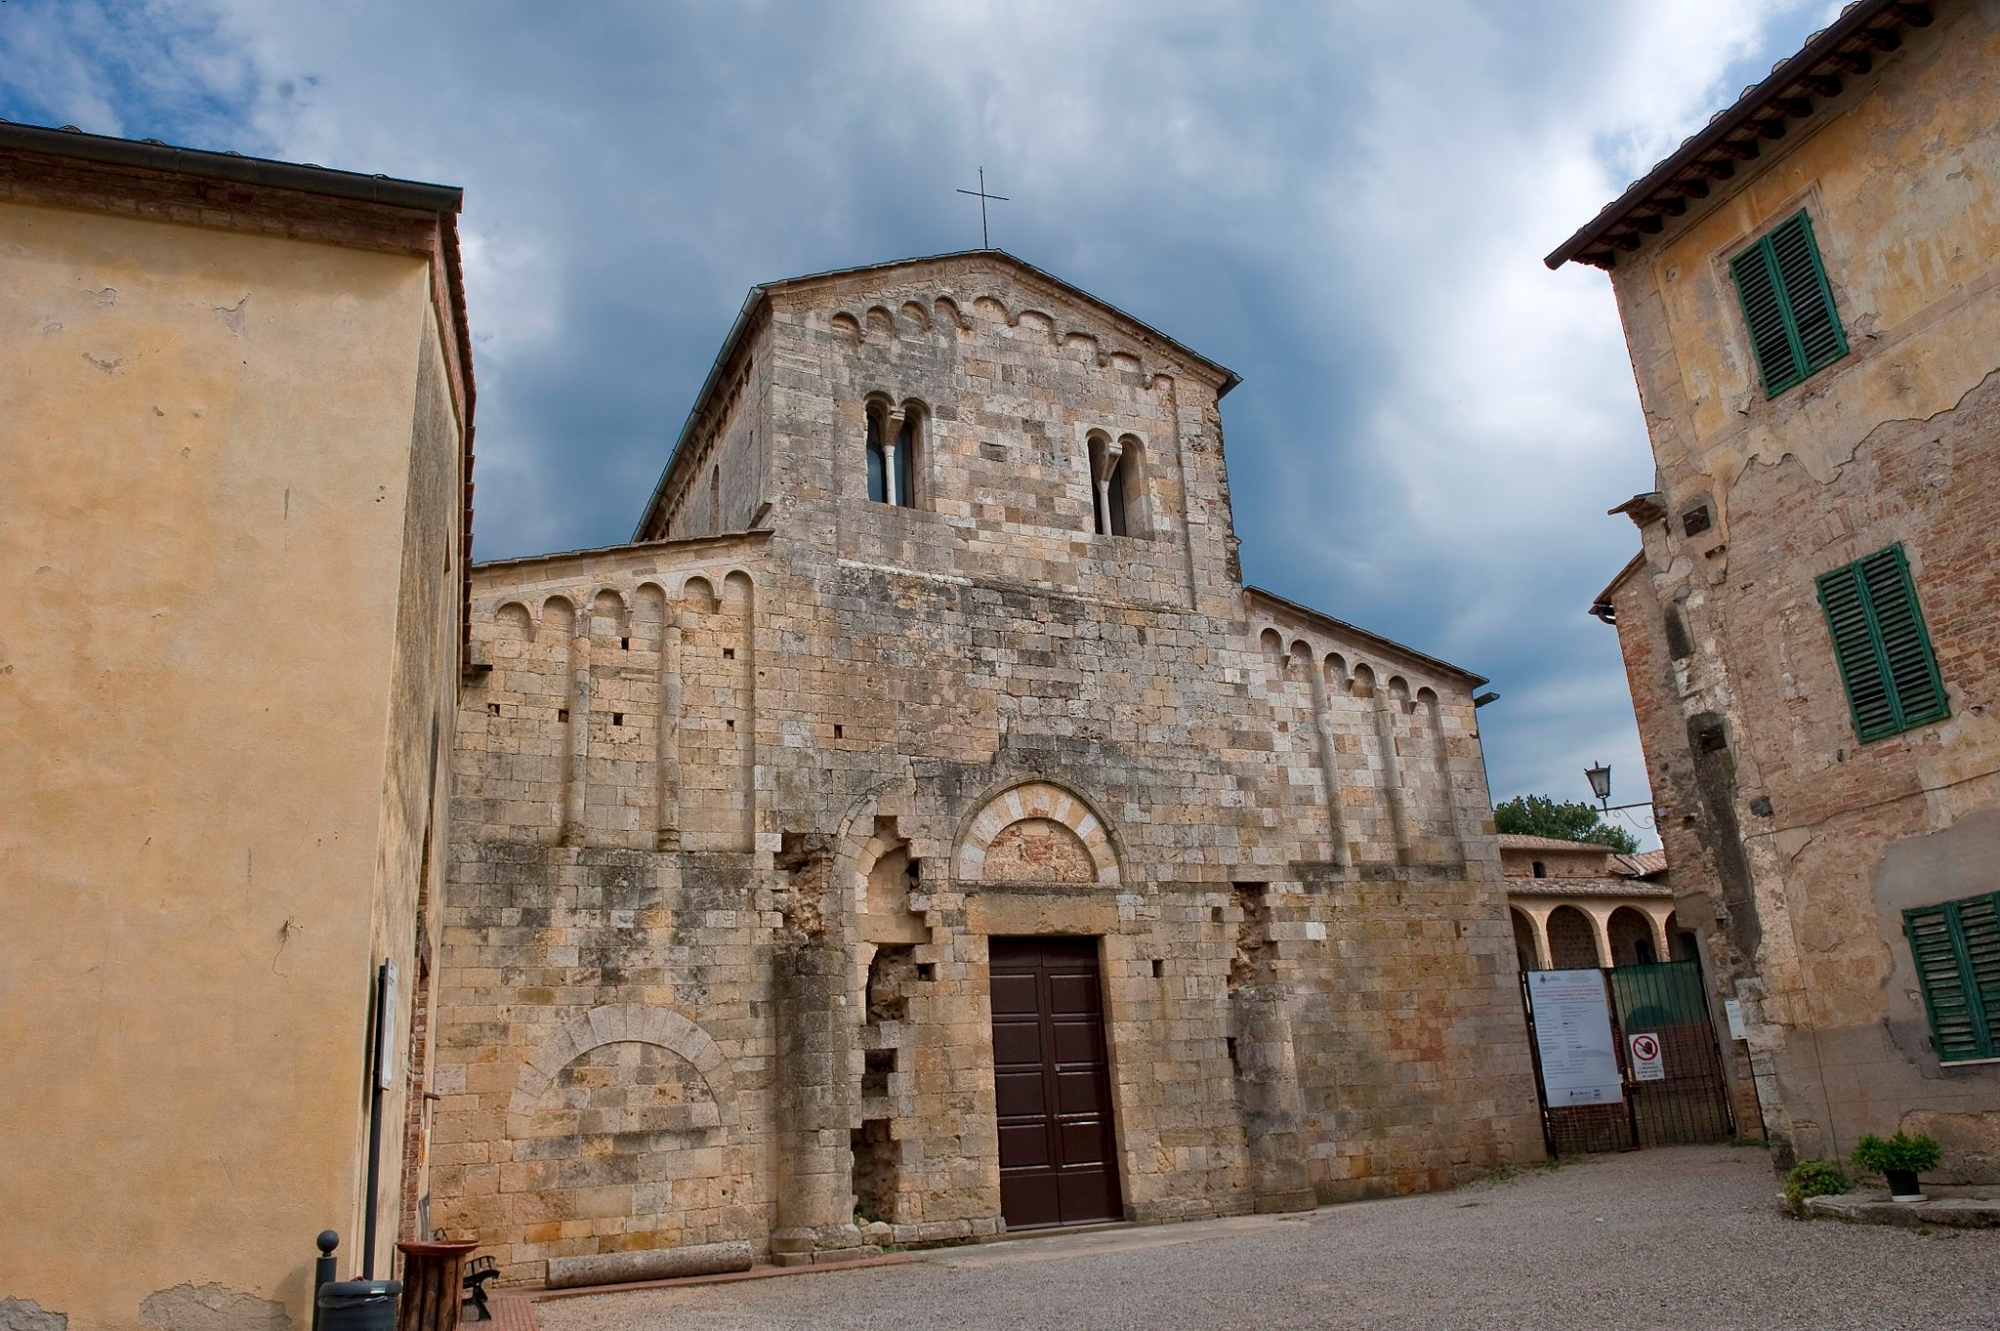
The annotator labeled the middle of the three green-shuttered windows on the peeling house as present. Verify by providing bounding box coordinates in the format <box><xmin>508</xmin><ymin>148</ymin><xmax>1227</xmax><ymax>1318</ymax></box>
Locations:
<box><xmin>1820</xmin><ymin>546</ymin><xmax>1952</xmax><ymax>743</ymax></box>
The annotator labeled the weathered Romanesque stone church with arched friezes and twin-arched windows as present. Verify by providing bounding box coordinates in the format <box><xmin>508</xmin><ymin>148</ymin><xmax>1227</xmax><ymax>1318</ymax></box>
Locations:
<box><xmin>428</xmin><ymin>252</ymin><xmax>1542</xmax><ymax>1281</ymax></box>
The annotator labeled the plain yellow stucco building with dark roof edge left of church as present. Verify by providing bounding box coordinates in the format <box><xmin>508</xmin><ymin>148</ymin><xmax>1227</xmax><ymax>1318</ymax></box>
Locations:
<box><xmin>0</xmin><ymin>124</ymin><xmax>472</xmax><ymax>1331</ymax></box>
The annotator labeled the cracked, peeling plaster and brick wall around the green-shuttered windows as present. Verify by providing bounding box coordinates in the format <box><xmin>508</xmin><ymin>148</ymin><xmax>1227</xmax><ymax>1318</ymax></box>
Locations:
<box><xmin>1614</xmin><ymin>4</ymin><xmax>2000</xmax><ymax>1179</ymax></box>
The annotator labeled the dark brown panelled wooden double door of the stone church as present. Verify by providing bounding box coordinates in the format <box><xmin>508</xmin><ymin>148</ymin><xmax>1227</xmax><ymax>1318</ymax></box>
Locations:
<box><xmin>988</xmin><ymin>937</ymin><xmax>1124</xmax><ymax>1229</ymax></box>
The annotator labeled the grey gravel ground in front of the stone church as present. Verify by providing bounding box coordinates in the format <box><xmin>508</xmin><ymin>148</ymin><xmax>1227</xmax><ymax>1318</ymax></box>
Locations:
<box><xmin>536</xmin><ymin>1147</ymin><xmax>2000</xmax><ymax>1331</ymax></box>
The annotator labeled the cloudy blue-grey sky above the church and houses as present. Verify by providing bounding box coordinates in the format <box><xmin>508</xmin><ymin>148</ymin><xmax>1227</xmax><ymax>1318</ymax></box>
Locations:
<box><xmin>0</xmin><ymin>0</ymin><xmax>1834</xmax><ymax>843</ymax></box>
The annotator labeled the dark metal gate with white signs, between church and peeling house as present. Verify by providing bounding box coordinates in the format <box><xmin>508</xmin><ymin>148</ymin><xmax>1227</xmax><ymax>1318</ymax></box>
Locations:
<box><xmin>1522</xmin><ymin>961</ymin><xmax>1736</xmax><ymax>1155</ymax></box>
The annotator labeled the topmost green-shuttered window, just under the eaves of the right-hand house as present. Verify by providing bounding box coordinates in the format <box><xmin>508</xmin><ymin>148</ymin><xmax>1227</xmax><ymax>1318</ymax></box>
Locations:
<box><xmin>1730</xmin><ymin>210</ymin><xmax>1848</xmax><ymax>398</ymax></box>
